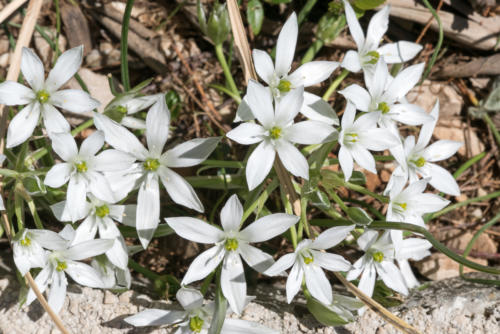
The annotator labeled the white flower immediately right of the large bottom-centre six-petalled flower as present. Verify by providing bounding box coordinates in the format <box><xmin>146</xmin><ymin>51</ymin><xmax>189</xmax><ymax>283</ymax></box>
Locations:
<box><xmin>264</xmin><ymin>225</ymin><xmax>354</xmax><ymax>305</ymax></box>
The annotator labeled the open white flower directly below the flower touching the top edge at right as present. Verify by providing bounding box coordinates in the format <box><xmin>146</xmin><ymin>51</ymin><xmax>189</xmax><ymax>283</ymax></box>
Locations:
<box><xmin>339</xmin><ymin>60</ymin><xmax>433</xmax><ymax>135</ymax></box>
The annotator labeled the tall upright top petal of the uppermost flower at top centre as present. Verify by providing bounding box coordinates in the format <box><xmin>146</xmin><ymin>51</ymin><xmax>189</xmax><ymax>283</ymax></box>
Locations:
<box><xmin>275</xmin><ymin>13</ymin><xmax>299</xmax><ymax>77</ymax></box>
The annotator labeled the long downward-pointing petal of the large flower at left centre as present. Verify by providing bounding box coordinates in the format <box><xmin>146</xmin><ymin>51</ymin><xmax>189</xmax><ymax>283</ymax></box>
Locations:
<box><xmin>135</xmin><ymin>175</ymin><xmax>160</xmax><ymax>249</ymax></box>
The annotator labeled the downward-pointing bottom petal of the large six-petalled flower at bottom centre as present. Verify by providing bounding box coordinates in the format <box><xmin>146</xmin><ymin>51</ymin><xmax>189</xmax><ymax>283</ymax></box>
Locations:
<box><xmin>220</xmin><ymin>252</ymin><xmax>247</xmax><ymax>314</ymax></box>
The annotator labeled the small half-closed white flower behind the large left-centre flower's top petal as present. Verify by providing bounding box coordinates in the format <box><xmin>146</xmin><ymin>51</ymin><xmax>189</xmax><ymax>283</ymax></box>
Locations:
<box><xmin>106</xmin><ymin>93</ymin><xmax>165</xmax><ymax>130</ymax></box>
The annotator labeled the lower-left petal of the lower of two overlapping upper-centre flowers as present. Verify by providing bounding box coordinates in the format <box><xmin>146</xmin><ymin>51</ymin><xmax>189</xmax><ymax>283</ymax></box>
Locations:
<box><xmin>245</xmin><ymin>140</ymin><xmax>276</xmax><ymax>190</ymax></box>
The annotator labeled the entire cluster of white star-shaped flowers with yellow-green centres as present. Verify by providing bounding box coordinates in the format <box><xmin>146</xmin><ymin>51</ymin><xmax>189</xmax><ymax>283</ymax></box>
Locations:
<box><xmin>0</xmin><ymin>1</ymin><xmax>461</xmax><ymax>333</ymax></box>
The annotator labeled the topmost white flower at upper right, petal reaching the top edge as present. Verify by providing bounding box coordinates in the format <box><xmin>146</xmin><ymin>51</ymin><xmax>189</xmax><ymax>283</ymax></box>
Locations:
<box><xmin>340</xmin><ymin>0</ymin><xmax>422</xmax><ymax>72</ymax></box>
